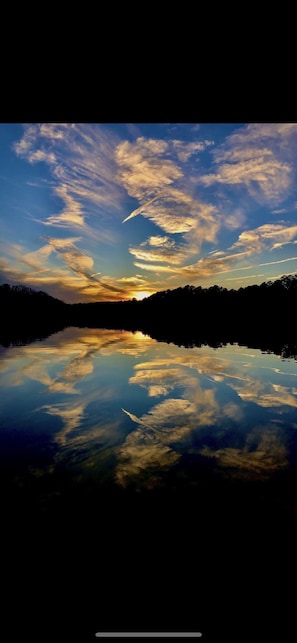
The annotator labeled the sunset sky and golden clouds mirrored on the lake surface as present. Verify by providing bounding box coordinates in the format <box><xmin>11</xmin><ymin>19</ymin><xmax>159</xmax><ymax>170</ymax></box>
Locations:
<box><xmin>0</xmin><ymin>328</ymin><xmax>297</xmax><ymax>496</ymax></box>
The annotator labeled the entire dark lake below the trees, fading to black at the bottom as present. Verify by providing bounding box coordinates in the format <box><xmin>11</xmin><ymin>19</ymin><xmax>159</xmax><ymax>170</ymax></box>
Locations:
<box><xmin>0</xmin><ymin>328</ymin><xmax>297</xmax><ymax>642</ymax></box>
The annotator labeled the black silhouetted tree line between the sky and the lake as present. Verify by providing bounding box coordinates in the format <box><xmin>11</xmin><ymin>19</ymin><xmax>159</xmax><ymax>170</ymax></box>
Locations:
<box><xmin>0</xmin><ymin>274</ymin><xmax>297</xmax><ymax>355</ymax></box>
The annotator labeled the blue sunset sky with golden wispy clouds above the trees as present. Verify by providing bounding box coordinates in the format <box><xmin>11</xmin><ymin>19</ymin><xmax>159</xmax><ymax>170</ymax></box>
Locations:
<box><xmin>0</xmin><ymin>122</ymin><xmax>297</xmax><ymax>303</ymax></box>
